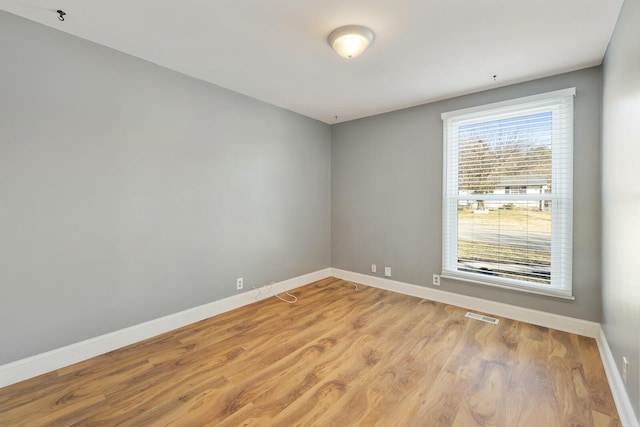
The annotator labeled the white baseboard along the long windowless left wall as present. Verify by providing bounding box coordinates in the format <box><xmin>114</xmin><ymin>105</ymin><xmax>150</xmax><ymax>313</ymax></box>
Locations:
<box><xmin>0</xmin><ymin>268</ymin><xmax>331</xmax><ymax>387</ymax></box>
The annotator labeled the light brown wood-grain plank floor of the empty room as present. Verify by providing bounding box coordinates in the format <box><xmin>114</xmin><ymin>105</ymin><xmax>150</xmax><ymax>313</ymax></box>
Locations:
<box><xmin>0</xmin><ymin>278</ymin><xmax>620</xmax><ymax>427</ymax></box>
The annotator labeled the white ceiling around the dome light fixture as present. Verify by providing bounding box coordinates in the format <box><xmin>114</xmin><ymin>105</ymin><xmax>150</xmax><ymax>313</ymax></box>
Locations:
<box><xmin>0</xmin><ymin>0</ymin><xmax>623</xmax><ymax>123</ymax></box>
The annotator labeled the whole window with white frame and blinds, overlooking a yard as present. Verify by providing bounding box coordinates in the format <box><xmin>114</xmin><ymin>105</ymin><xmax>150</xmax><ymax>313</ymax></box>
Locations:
<box><xmin>442</xmin><ymin>88</ymin><xmax>575</xmax><ymax>298</ymax></box>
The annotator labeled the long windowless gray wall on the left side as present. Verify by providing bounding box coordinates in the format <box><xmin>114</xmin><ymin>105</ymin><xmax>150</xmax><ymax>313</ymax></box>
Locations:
<box><xmin>0</xmin><ymin>12</ymin><xmax>331</xmax><ymax>364</ymax></box>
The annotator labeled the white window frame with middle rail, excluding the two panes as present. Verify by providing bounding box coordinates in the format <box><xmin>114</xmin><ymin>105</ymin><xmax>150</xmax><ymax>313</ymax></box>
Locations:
<box><xmin>441</xmin><ymin>88</ymin><xmax>576</xmax><ymax>299</ymax></box>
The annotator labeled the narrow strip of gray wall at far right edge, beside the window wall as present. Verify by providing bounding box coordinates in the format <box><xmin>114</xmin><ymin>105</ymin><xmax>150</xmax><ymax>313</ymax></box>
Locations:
<box><xmin>602</xmin><ymin>0</ymin><xmax>640</xmax><ymax>421</ymax></box>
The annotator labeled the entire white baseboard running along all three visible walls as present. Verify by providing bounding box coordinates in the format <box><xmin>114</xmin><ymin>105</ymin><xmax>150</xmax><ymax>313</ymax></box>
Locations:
<box><xmin>0</xmin><ymin>268</ymin><xmax>640</xmax><ymax>427</ymax></box>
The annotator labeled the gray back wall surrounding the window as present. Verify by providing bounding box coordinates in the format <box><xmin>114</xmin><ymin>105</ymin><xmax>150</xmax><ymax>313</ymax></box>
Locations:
<box><xmin>331</xmin><ymin>67</ymin><xmax>602</xmax><ymax>321</ymax></box>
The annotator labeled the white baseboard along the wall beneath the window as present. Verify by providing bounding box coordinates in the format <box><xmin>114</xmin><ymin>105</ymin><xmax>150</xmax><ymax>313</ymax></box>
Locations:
<box><xmin>331</xmin><ymin>268</ymin><xmax>600</xmax><ymax>338</ymax></box>
